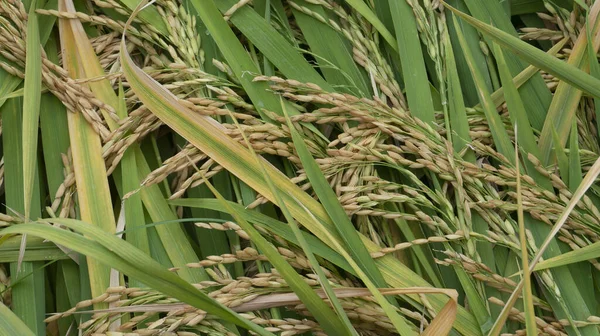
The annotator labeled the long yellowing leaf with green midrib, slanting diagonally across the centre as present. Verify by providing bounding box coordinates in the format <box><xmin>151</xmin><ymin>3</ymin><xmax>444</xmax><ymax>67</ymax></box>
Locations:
<box><xmin>120</xmin><ymin>10</ymin><xmax>479</xmax><ymax>334</ymax></box>
